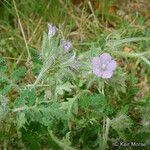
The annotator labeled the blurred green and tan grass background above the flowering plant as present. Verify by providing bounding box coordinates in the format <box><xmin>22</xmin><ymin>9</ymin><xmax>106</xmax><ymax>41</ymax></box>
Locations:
<box><xmin>0</xmin><ymin>0</ymin><xmax>150</xmax><ymax>58</ymax></box>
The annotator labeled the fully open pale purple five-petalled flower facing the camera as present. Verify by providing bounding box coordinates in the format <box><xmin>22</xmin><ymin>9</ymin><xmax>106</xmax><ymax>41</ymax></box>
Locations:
<box><xmin>92</xmin><ymin>53</ymin><xmax>117</xmax><ymax>79</ymax></box>
